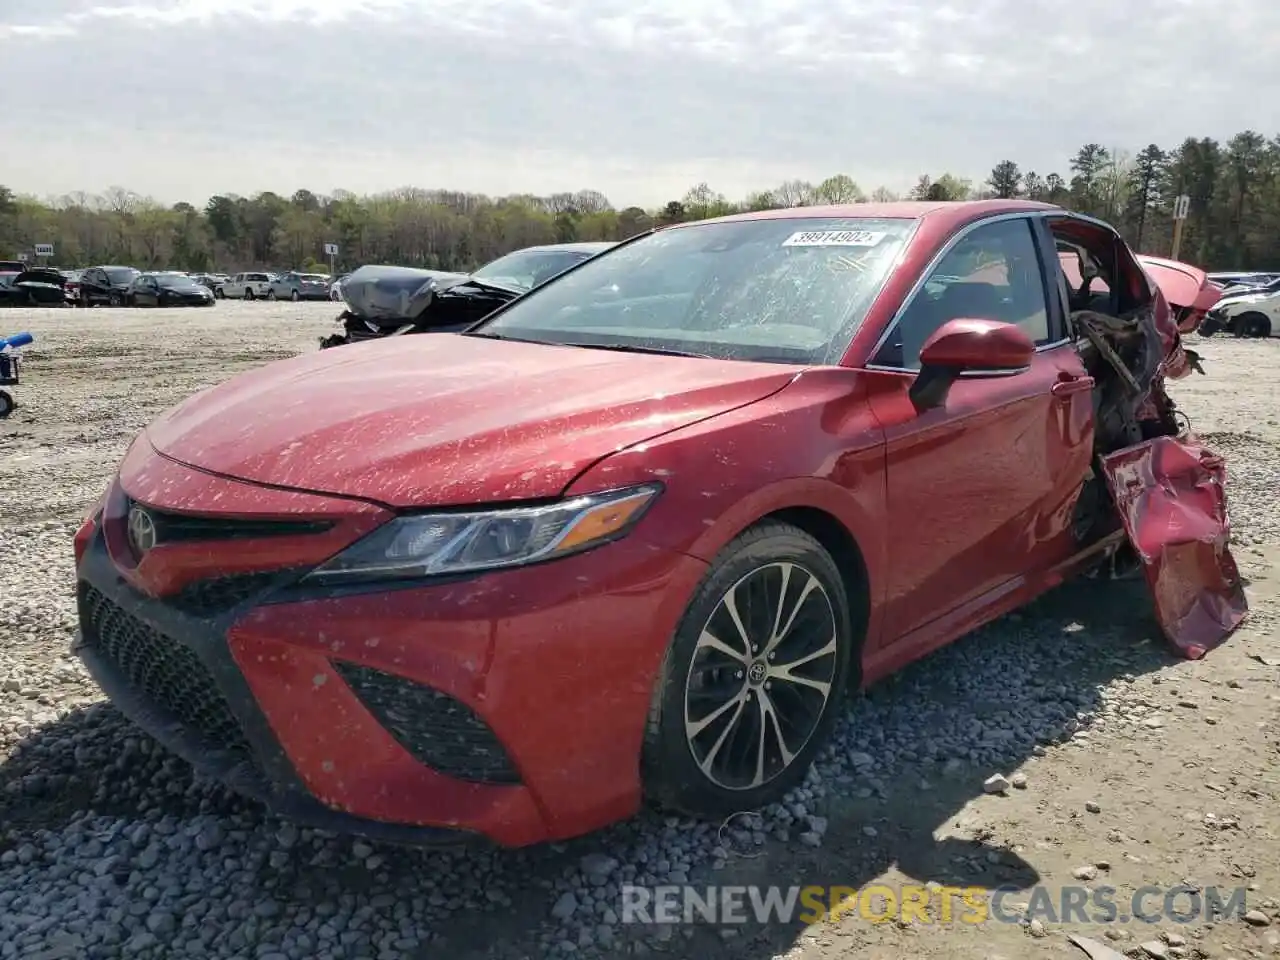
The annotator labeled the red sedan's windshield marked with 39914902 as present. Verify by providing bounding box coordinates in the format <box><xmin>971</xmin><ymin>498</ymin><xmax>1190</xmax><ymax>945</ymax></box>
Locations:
<box><xmin>479</xmin><ymin>218</ymin><xmax>915</xmax><ymax>364</ymax></box>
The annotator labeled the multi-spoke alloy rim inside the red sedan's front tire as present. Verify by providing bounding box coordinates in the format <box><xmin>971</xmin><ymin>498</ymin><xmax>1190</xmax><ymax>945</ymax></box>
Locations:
<box><xmin>685</xmin><ymin>562</ymin><xmax>838</xmax><ymax>791</ymax></box>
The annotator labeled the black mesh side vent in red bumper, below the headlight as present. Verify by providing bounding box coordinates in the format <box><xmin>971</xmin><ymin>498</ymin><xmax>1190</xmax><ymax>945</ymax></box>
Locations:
<box><xmin>333</xmin><ymin>660</ymin><xmax>520</xmax><ymax>783</ymax></box>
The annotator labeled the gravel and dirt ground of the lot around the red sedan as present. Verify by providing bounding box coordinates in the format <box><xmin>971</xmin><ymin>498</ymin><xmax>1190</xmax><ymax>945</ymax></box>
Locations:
<box><xmin>0</xmin><ymin>302</ymin><xmax>1280</xmax><ymax>960</ymax></box>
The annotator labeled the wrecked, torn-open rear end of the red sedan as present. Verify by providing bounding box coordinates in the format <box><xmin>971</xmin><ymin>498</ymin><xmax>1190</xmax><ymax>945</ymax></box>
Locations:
<box><xmin>1052</xmin><ymin>224</ymin><xmax>1248</xmax><ymax>659</ymax></box>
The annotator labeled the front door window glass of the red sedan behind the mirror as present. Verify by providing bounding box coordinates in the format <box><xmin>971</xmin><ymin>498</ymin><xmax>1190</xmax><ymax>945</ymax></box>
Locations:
<box><xmin>872</xmin><ymin>219</ymin><xmax>1056</xmax><ymax>370</ymax></box>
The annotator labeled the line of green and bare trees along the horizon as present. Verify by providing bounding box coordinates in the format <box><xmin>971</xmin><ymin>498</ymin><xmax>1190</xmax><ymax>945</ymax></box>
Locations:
<box><xmin>0</xmin><ymin>131</ymin><xmax>1280</xmax><ymax>270</ymax></box>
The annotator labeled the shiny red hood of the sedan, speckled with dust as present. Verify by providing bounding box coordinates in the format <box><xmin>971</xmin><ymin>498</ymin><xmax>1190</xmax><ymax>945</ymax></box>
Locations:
<box><xmin>147</xmin><ymin>334</ymin><xmax>797</xmax><ymax>507</ymax></box>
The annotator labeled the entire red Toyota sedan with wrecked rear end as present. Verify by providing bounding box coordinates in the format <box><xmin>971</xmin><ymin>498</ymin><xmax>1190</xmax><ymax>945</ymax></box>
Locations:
<box><xmin>76</xmin><ymin>201</ymin><xmax>1244</xmax><ymax>846</ymax></box>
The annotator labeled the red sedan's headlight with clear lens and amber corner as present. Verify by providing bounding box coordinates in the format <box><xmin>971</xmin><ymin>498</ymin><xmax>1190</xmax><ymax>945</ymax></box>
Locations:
<box><xmin>303</xmin><ymin>485</ymin><xmax>660</xmax><ymax>584</ymax></box>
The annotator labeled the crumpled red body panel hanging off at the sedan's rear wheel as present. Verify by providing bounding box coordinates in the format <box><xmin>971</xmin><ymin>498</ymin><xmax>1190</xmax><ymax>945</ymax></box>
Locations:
<box><xmin>1102</xmin><ymin>436</ymin><xmax>1249</xmax><ymax>660</ymax></box>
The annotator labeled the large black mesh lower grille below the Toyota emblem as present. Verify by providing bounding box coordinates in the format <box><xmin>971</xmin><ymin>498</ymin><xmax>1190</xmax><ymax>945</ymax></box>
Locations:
<box><xmin>79</xmin><ymin>582</ymin><xmax>252</xmax><ymax>759</ymax></box>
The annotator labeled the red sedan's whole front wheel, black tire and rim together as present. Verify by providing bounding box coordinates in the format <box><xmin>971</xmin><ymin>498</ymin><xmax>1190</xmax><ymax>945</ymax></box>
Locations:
<box><xmin>640</xmin><ymin>522</ymin><xmax>861</xmax><ymax>819</ymax></box>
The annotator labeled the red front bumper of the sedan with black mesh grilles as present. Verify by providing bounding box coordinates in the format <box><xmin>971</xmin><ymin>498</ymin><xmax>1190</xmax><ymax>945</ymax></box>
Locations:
<box><xmin>77</xmin><ymin>454</ymin><xmax>705</xmax><ymax>846</ymax></box>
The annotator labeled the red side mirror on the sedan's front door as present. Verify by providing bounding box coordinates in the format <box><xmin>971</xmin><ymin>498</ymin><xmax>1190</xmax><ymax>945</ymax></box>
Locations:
<box><xmin>909</xmin><ymin>320</ymin><xmax>1036</xmax><ymax>413</ymax></box>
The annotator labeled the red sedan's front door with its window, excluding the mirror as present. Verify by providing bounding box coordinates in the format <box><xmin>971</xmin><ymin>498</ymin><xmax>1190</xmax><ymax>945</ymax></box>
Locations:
<box><xmin>868</xmin><ymin>215</ymin><xmax>1093</xmax><ymax>645</ymax></box>
